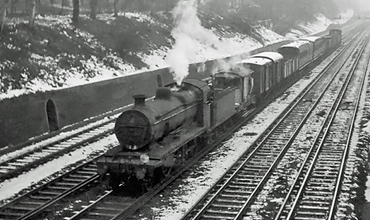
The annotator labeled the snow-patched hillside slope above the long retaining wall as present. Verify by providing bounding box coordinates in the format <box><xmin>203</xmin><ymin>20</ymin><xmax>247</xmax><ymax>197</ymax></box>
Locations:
<box><xmin>0</xmin><ymin>3</ymin><xmax>352</xmax><ymax>100</ymax></box>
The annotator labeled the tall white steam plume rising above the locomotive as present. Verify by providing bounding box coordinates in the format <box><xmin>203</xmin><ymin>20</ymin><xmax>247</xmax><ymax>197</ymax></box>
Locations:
<box><xmin>166</xmin><ymin>0</ymin><xmax>219</xmax><ymax>85</ymax></box>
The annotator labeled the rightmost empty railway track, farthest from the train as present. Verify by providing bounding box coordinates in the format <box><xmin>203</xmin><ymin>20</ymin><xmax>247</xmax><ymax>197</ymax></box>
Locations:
<box><xmin>275</xmin><ymin>35</ymin><xmax>369</xmax><ymax>219</ymax></box>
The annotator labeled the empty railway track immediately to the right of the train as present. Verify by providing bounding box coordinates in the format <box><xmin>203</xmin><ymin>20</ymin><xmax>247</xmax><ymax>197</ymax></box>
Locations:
<box><xmin>179</xmin><ymin>27</ymin><xmax>368</xmax><ymax>219</ymax></box>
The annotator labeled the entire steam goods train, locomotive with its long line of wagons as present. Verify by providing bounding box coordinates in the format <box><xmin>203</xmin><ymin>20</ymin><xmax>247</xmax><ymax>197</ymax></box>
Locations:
<box><xmin>98</xmin><ymin>29</ymin><xmax>342</xmax><ymax>190</ymax></box>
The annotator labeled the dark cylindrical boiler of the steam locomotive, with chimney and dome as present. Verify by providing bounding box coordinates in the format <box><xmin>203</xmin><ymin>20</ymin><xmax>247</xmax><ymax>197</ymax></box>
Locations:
<box><xmin>114</xmin><ymin>83</ymin><xmax>202</xmax><ymax>150</ymax></box>
